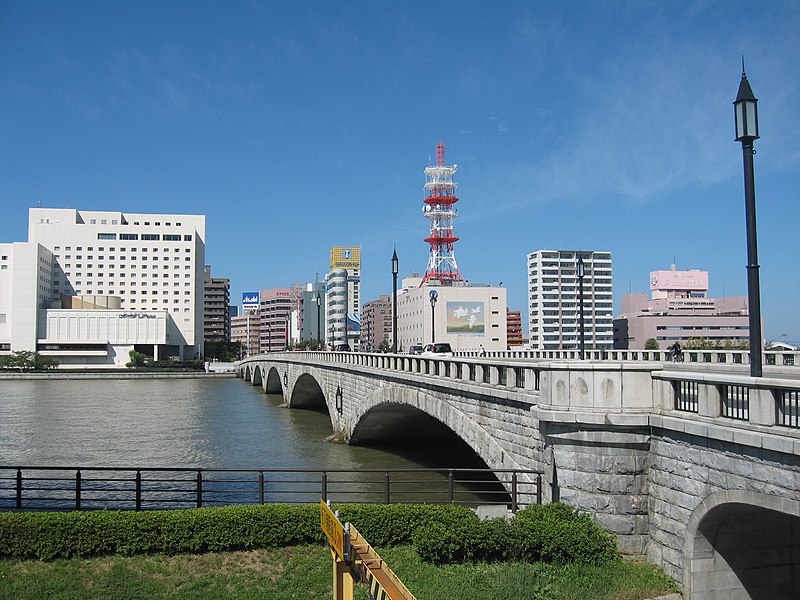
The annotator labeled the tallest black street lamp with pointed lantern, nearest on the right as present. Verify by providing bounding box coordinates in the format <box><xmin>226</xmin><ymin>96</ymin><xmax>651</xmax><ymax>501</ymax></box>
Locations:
<box><xmin>733</xmin><ymin>63</ymin><xmax>761</xmax><ymax>377</ymax></box>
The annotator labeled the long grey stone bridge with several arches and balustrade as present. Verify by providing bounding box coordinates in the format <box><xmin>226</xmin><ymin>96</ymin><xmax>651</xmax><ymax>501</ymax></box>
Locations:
<box><xmin>237</xmin><ymin>352</ymin><xmax>800</xmax><ymax>600</ymax></box>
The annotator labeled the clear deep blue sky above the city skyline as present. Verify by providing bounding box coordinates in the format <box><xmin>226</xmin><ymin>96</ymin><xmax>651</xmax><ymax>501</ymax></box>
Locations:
<box><xmin>0</xmin><ymin>0</ymin><xmax>800</xmax><ymax>340</ymax></box>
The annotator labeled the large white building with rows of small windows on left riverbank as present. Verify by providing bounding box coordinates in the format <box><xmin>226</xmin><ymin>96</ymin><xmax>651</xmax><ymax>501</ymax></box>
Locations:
<box><xmin>0</xmin><ymin>208</ymin><xmax>205</xmax><ymax>366</ymax></box>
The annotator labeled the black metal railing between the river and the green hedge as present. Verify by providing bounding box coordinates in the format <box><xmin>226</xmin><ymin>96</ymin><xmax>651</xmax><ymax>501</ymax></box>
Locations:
<box><xmin>0</xmin><ymin>466</ymin><xmax>542</xmax><ymax>511</ymax></box>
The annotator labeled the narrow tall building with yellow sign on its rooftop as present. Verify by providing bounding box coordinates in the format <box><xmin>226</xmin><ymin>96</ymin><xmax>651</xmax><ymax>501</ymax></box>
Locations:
<box><xmin>325</xmin><ymin>246</ymin><xmax>361</xmax><ymax>350</ymax></box>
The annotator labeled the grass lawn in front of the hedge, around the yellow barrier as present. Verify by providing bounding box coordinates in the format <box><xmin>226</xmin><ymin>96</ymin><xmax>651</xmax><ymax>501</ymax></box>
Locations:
<box><xmin>0</xmin><ymin>546</ymin><xmax>677</xmax><ymax>600</ymax></box>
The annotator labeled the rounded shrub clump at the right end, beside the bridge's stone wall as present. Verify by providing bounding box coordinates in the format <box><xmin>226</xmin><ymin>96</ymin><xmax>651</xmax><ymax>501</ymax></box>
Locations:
<box><xmin>414</xmin><ymin>503</ymin><xmax>619</xmax><ymax>564</ymax></box>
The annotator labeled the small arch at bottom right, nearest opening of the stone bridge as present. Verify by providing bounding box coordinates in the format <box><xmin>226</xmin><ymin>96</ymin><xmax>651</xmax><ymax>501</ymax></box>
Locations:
<box><xmin>684</xmin><ymin>490</ymin><xmax>800</xmax><ymax>600</ymax></box>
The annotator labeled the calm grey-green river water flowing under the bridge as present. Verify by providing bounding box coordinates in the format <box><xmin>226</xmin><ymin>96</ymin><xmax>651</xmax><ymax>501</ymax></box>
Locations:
<box><xmin>0</xmin><ymin>377</ymin><xmax>506</xmax><ymax>508</ymax></box>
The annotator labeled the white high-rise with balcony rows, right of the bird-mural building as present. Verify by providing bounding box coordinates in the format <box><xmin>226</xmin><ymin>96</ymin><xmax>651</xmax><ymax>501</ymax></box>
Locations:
<box><xmin>528</xmin><ymin>250</ymin><xmax>613</xmax><ymax>350</ymax></box>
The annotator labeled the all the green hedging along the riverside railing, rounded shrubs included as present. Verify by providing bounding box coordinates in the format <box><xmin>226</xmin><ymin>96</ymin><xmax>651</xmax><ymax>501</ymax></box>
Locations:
<box><xmin>0</xmin><ymin>504</ymin><xmax>619</xmax><ymax>564</ymax></box>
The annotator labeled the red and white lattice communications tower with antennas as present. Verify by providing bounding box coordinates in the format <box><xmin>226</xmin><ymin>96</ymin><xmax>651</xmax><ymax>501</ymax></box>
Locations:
<box><xmin>421</xmin><ymin>142</ymin><xmax>464</xmax><ymax>285</ymax></box>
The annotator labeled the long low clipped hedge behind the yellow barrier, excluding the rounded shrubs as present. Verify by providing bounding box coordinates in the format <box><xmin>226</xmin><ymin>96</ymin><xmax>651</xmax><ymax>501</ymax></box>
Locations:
<box><xmin>0</xmin><ymin>504</ymin><xmax>477</xmax><ymax>560</ymax></box>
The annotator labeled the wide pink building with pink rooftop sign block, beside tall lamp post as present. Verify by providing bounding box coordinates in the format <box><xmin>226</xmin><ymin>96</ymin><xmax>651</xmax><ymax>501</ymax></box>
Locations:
<box><xmin>614</xmin><ymin>265</ymin><xmax>750</xmax><ymax>350</ymax></box>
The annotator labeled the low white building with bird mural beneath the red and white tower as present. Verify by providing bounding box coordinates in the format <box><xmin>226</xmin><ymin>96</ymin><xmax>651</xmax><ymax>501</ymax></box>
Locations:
<box><xmin>397</xmin><ymin>277</ymin><xmax>507</xmax><ymax>352</ymax></box>
